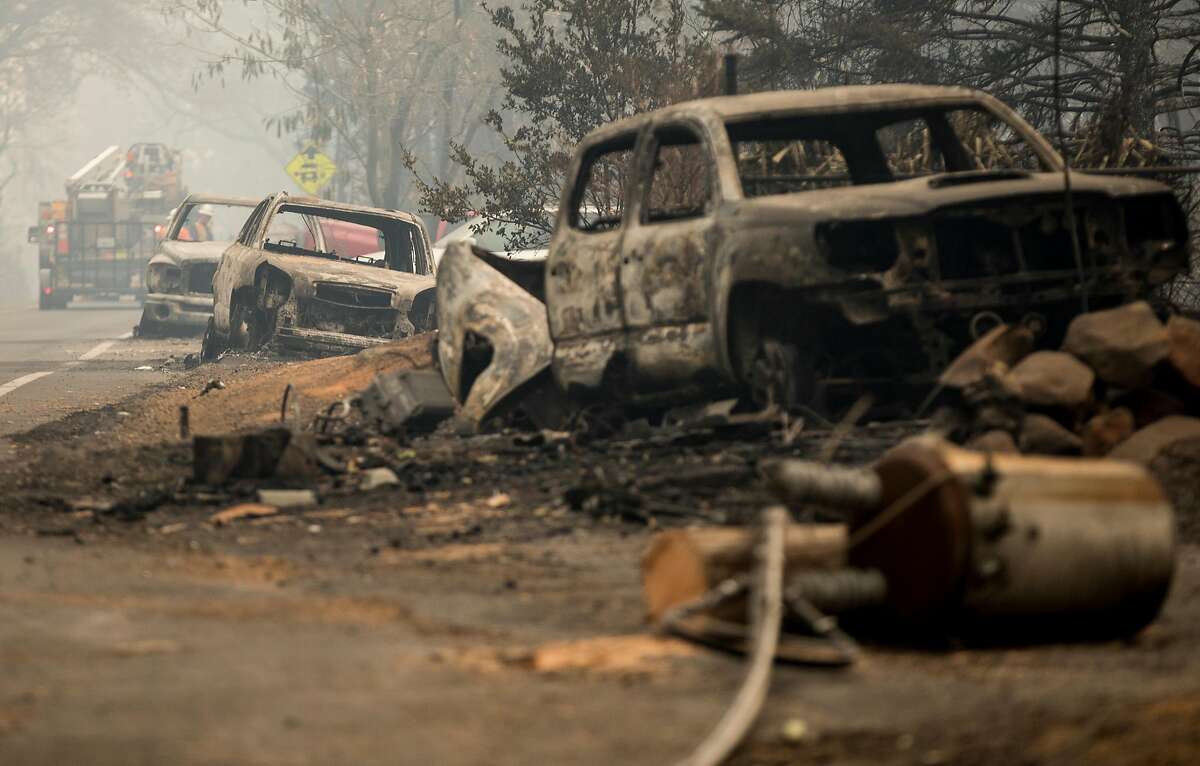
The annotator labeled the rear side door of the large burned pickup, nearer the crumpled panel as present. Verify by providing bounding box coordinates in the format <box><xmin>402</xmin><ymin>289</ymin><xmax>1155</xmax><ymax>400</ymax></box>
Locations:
<box><xmin>546</xmin><ymin>130</ymin><xmax>637</xmax><ymax>388</ymax></box>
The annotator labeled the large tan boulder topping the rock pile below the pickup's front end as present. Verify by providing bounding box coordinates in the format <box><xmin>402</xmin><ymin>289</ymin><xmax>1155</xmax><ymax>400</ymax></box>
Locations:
<box><xmin>1062</xmin><ymin>301</ymin><xmax>1169</xmax><ymax>388</ymax></box>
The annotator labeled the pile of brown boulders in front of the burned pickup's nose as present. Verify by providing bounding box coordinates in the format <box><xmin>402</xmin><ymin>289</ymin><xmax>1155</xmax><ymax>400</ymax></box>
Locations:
<box><xmin>936</xmin><ymin>301</ymin><xmax>1200</xmax><ymax>525</ymax></box>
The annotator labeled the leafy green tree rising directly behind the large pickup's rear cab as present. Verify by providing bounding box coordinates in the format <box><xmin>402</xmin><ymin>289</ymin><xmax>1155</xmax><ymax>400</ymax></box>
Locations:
<box><xmin>407</xmin><ymin>0</ymin><xmax>716</xmax><ymax>249</ymax></box>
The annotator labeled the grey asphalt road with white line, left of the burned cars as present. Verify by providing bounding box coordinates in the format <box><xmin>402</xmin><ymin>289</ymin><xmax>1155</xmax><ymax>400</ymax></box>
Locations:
<box><xmin>0</xmin><ymin>303</ymin><xmax>199</xmax><ymax>441</ymax></box>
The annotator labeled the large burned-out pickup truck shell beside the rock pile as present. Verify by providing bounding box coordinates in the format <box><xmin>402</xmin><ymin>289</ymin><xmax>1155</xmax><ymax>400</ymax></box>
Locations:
<box><xmin>438</xmin><ymin>85</ymin><xmax>1189</xmax><ymax>429</ymax></box>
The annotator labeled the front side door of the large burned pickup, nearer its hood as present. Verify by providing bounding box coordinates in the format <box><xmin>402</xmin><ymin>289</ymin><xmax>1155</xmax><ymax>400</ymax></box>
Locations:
<box><xmin>620</xmin><ymin>121</ymin><xmax>716</xmax><ymax>389</ymax></box>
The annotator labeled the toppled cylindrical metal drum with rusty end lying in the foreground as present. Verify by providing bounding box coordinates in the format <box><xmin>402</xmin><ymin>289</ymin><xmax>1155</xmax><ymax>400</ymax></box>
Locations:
<box><xmin>848</xmin><ymin>437</ymin><xmax>1175</xmax><ymax>638</ymax></box>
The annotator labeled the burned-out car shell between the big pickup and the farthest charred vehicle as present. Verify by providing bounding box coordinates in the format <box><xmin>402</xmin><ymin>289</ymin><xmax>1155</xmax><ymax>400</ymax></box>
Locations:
<box><xmin>203</xmin><ymin>192</ymin><xmax>436</xmax><ymax>359</ymax></box>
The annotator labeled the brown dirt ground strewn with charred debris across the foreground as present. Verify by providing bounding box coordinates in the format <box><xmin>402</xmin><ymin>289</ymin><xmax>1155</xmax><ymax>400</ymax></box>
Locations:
<box><xmin>0</xmin><ymin>339</ymin><xmax>1200</xmax><ymax>766</ymax></box>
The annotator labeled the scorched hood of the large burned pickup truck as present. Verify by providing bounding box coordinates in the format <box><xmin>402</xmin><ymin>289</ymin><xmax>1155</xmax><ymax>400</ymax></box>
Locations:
<box><xmin>738</xmin><ymin>172</ymin><xmax>1170</xmax><ymax>223</ymax></box>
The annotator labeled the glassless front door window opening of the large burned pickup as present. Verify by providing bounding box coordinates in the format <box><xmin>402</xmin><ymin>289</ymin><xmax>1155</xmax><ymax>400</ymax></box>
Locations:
<box><xmin>643</xmin><ymin>127</ymin><xmax>713</xmax><ymax>223</ymax></box>
